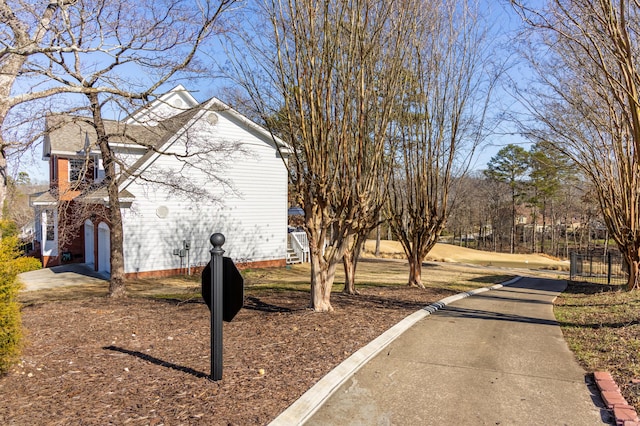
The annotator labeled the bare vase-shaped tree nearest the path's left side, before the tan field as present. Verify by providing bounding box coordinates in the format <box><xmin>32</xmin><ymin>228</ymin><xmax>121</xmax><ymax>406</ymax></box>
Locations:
<box><xmin>387</xmin><ymin>1</ymin><xmax>495</xmax><ymax>287</ymax></box>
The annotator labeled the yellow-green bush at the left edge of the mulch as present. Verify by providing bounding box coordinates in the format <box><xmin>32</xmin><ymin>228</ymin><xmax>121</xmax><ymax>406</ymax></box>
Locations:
<box><xmin>0</xmin><ymin>237</ymin><xmax>25</xmax><ymax>373</ymax></box>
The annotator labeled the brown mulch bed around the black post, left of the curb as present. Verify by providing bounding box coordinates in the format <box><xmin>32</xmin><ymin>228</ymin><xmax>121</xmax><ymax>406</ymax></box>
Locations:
<box><xmin>0</xmin><ymin>286</ymin><xmax>453</xmax><ymax>425</ymax></box>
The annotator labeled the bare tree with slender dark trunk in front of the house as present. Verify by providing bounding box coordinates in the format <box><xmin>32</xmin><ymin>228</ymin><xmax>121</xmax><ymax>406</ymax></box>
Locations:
<box><xmin>7</xmin><ymin>0</ymin><xmax>233</xmax><ymax>297</ymax></box>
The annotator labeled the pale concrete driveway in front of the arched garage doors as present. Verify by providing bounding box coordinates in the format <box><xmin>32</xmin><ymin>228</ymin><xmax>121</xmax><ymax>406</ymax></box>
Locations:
<box><xmin>18</xmin><ymin>263</ymin><xmax>109</xmax><ymax>291</ymax></box>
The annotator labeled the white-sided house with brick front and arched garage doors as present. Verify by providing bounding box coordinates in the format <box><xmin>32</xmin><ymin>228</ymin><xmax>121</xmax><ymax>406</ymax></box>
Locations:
<box><xmin>31</xmin><ymin>86</ymin><xmax>287</xmax><ymax>276</ymax></box>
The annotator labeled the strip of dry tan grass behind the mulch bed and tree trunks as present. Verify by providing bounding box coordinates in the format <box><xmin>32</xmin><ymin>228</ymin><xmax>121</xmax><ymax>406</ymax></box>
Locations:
<box><xmin>20</xmin><ymin>240</ymin><xmax>565</xmax><ymax>304</ymax></box>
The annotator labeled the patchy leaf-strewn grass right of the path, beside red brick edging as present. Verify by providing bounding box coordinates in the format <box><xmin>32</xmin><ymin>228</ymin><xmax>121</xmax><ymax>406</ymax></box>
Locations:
<box><xmin>555</xmin><ymin>283</ymin><xmax>640</xmax><ymax>410</ymax></box>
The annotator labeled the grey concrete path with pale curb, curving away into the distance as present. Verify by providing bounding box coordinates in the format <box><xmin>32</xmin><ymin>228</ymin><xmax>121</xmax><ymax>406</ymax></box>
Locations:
<box><xmin>272</xmin><ymin>278</ymin><xmax>609</xmax><ymax>426</ymax></box>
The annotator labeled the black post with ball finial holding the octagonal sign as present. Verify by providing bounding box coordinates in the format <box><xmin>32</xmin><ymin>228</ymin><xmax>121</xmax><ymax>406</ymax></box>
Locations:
<box><xmin>209</xmin><ymin>233</ymin><xmax>224</xmax><ymax>381</ymax></box>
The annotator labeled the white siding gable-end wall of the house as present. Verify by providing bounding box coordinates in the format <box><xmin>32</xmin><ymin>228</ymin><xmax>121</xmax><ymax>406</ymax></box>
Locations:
<box><xmin>123</xmin><ymin>106</ymin><xmax>287</xmax><ymax>272</ymax></box>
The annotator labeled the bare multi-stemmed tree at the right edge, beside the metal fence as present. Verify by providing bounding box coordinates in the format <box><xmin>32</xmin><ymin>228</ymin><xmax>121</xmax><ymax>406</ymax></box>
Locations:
<box><xmin>512</xmin><ymin>0</ymin><xmax>640</xmax><ymax>290</ymax></box>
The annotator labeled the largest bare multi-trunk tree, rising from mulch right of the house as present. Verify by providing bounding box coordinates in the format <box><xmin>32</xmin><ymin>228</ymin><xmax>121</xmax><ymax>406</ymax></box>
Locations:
<box><xmin>234</xmin><ymin>0</ymin><xmax>415</xmax><ymax>311</ymax></box>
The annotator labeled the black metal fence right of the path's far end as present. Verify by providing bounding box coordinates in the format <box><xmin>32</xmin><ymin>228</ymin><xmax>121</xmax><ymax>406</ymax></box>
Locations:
<box><xmin>570</xmin><ymin>252</ymin><xmax>629</xmax><ymax>284</ymax></box>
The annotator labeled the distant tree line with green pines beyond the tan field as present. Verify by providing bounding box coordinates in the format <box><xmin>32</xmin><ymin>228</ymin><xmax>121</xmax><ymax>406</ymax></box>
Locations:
<box><xmin>443</xmin><ymin>142</ymin><xmax>610</xmax><ymax>258</ymax></box>
